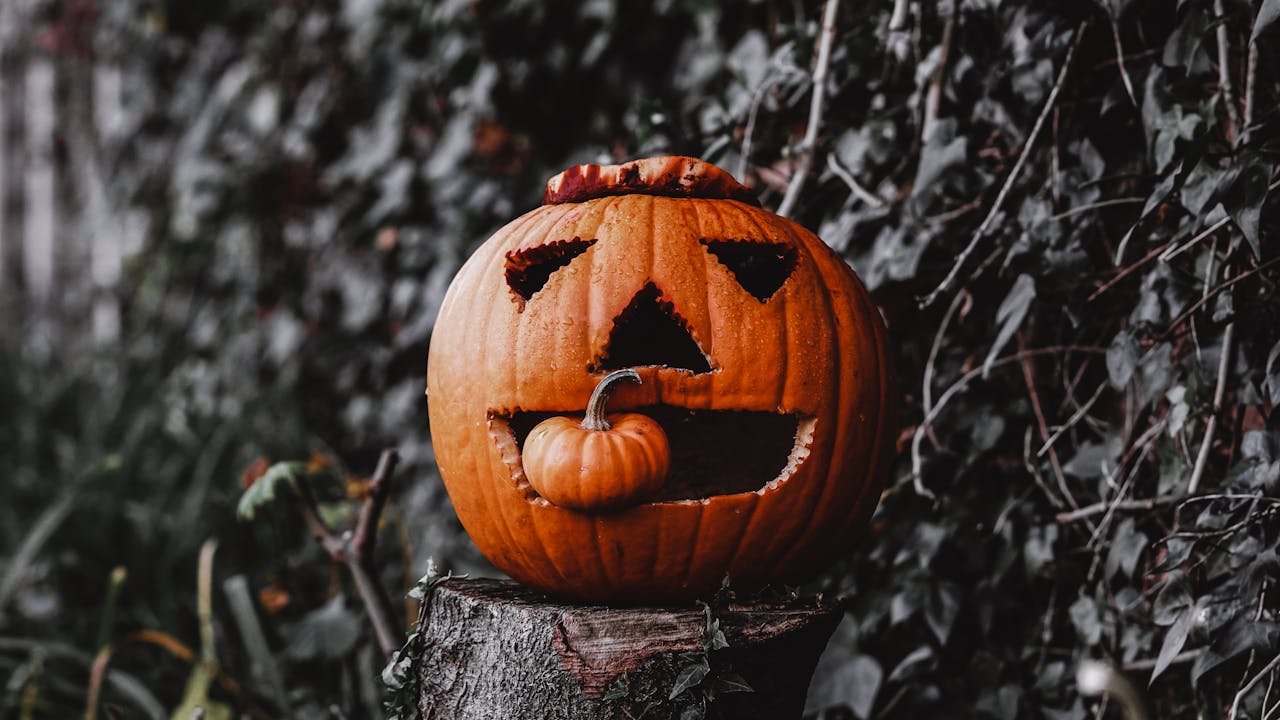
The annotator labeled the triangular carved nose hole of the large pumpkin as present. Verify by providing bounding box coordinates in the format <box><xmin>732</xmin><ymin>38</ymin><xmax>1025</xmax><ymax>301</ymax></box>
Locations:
<box><xmin>591</xmin><ymin>283</ymin><xmax>712</xmax><ymax>373</ymax></box>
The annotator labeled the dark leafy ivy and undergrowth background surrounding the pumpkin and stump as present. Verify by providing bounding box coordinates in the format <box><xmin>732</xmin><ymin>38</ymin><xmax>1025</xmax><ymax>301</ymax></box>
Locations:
<box><xmin>0</xmin><ymin>0</ymin><xmax>1280</xmax><ymax>720</ymax></box>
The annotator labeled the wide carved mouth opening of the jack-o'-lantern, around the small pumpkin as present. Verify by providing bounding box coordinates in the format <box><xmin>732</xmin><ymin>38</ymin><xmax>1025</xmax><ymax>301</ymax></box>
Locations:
<box><xmin>489</xmin><ymin>405</ymin><xmax>814</xmax><ymax>502</ymax></box>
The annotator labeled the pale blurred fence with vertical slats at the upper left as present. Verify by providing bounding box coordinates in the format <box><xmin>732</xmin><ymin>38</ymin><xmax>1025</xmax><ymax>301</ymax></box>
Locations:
<box><xmin>0</xmin><ymin>0</ymin><xmax>141</xmax><ymax>342</ymax></box>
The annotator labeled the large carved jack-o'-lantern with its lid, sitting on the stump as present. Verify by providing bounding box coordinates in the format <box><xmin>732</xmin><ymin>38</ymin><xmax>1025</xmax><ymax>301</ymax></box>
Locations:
<box><xmin>428</xmin><ymin>158</ymin><xmax>897</xmax><ymax>605</ymax></box>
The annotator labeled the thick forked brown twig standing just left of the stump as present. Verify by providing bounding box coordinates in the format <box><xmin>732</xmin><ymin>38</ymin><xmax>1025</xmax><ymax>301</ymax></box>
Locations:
<box><xmin>293</xmin><ymin>450</ymin><xmax>399</xmax><ymax>657</ymax></box>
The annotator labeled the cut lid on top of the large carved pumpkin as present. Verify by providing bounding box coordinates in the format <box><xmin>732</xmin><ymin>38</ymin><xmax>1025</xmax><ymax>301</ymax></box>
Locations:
<box><xmin>543</xmin><ymin>155</ymin><xmax>760</xmax><ymax>205</ymax></box>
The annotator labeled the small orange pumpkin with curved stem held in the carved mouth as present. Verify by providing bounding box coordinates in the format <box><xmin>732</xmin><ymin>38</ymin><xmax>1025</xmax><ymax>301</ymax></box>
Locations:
<box><xmin>525</xmin><ymin>370</ymin><xmax>671</xmax><ymax>512</ymax></box>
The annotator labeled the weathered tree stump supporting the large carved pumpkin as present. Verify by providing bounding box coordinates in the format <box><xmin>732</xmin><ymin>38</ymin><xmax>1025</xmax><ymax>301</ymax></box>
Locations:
<box><xmin>416</xmin><ymin>579</ymin><xmax>842</xmax><ymax>720</ymax></box>
